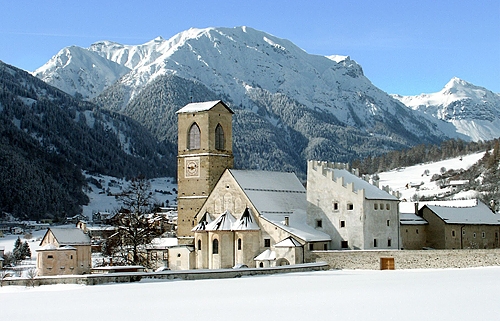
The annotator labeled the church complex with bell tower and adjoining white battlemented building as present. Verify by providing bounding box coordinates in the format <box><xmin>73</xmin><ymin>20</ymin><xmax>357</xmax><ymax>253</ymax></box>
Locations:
<box><xmin>172</xmin><ymin>101</ymin><xmax>399</xmax><ymax>269</ymax></box>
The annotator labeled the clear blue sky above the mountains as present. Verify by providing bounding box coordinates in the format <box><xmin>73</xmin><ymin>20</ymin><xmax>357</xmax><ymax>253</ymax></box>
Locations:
<box><xmin>0</xmin><ymin>0</ymin><xmax>500</xmax><ymax>95</ymax></box>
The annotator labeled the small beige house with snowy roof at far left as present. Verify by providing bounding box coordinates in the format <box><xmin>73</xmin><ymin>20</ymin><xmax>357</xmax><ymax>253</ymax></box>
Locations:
<box><xmin>36</xmin><ymin>228</ymin><xmax>92</xmax><ymax>276</ymax></box>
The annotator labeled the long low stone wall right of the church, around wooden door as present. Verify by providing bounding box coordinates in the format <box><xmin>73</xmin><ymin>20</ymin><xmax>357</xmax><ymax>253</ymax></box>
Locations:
<box><xmin>309</xmin><ymin>249</ymin><xmax>500</xmax><ymax>270</ymax></box>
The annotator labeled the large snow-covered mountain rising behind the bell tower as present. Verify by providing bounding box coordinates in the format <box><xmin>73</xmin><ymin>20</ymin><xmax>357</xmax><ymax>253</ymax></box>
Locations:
<box><xmin>35</xmin><ymin>27</ymin><xmax>460</xmax><ymax>173</ymax></box>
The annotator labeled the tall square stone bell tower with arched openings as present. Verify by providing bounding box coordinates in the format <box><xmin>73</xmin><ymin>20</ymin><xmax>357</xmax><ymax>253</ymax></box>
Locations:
<box><xmin>177</xmin><ymin>100</ymin><xmax>234</xmax><ymax>245</ymax></box>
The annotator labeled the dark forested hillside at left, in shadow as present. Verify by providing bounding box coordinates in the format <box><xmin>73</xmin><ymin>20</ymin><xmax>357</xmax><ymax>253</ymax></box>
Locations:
<box><xmin>0</xmin><ymin>62</ymin><xmax>176</xmax><ymax>219</ymax></box>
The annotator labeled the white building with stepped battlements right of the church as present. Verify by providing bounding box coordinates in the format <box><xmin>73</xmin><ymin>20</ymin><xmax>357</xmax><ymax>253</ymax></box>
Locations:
<box><xmin>307</xmin><ymin>161</ymin><xmax>401</xmax><ymax>250</ymax></box>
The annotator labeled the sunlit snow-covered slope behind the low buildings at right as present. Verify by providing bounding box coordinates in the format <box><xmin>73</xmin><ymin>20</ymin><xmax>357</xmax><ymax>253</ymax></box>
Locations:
<box><xmin>379</xmin><ymin>152</ymin><xmax>484</xmax><ymax>201</ymax></box>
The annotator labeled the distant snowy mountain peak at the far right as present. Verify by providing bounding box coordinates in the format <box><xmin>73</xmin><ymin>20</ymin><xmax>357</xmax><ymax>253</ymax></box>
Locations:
<box><xmin>393</xmin><ymin>77</ymin><xmax>500</xmax><ymax>141</ymax></box>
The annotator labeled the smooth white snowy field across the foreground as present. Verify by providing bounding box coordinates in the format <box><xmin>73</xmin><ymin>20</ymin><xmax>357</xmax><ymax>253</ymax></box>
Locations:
<box><xmin>0</xmin><ymin>267</ymin><xmax>500</xmax><ymax>321</ymax></box>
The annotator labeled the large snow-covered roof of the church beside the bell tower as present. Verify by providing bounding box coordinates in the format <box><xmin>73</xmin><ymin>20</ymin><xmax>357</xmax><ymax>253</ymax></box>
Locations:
<box><xmin>229</xmin><ymin>169</ymin><xmax>331</xmax><ymax>242</ymax></box>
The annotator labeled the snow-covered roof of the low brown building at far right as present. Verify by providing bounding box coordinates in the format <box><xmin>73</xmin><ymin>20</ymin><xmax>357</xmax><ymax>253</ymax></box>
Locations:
<box><xmin>425</xmin><ymin>201</ymin><xmax>500</xmax><ymax>225</ymax></box>
